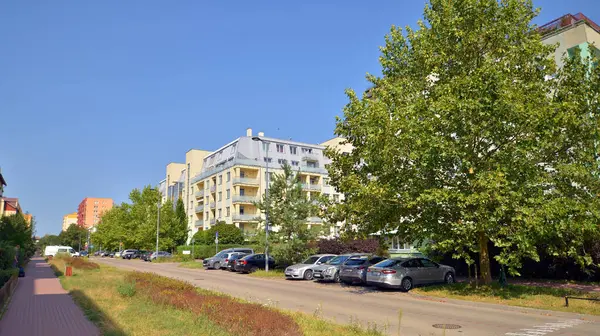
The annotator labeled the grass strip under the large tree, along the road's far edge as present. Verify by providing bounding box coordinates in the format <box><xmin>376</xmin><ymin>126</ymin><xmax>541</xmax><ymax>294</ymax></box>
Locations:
<box><xmin>413</xmin><ymin>283</ymin><xmax>600</xmax><ymax>315</ymax></box>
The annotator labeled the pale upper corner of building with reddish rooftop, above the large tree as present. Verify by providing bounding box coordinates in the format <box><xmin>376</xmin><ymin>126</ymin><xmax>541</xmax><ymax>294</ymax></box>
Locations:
<box><xmin>538</xmin><ymin>13</ymin><xmax>600</xmax><ymax>67</ymax></box>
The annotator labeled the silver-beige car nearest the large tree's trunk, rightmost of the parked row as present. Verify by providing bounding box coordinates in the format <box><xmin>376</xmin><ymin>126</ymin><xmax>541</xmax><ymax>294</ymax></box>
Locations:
<box><xmin>367</xmin><ymin>258</ymin><xmax>456</xmax><ymax>292</ymax></box>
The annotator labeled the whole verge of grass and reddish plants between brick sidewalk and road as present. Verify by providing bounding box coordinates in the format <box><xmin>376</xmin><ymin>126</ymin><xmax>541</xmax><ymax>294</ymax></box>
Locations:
<box><xmin>51</xmin><ymin>259</ymin><xmax>382</xmax><ymax>336</ymax></box>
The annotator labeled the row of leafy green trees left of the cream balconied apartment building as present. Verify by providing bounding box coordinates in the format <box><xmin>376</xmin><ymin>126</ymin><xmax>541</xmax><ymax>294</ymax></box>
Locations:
<box><xmin>91</xmin><ymin>186</ymin><xmax>188</xmax><ymax>251</ymax></box>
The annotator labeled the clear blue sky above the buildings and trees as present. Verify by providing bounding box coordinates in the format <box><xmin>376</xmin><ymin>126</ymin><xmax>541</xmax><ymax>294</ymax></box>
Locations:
<box><xmin>0</xmin><ymin>0</ymin><xmax>600</xmax><ymax>235</ymax></box>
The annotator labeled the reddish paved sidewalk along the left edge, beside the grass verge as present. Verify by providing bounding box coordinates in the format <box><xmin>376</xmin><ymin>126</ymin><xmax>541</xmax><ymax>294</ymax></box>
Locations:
<box><xmin>0</xmin><ymin>258</ymin><xmax>100</xmax><ymax>336</ymax></box>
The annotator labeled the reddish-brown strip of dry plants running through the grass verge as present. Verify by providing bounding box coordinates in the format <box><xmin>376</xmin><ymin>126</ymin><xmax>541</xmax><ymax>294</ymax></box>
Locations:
<box><xmin>128</xmin><ymin>272</ymin><xmax>303</xmax><ymax>336</ymax></box>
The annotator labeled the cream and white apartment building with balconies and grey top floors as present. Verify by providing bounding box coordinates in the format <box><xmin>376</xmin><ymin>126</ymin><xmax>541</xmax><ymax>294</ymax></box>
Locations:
<box><xmin>190</xmin><ymin>129</ymin><xmax>341</xmax><ymax>235</ymax></box>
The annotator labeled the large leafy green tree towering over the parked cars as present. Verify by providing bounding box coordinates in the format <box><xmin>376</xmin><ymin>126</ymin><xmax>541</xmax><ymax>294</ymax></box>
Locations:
<box><xmin>328</xmin><ymin>0</ymin><xmax>600</xmax><ymax>283</ymax></box>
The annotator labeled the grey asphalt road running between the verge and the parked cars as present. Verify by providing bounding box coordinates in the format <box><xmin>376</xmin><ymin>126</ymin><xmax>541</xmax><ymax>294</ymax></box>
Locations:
<box><xmin>94</xmin><ymin>258</ymin><xmax>600</xmax><ymax>336</ymax></box>
